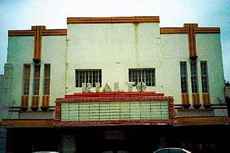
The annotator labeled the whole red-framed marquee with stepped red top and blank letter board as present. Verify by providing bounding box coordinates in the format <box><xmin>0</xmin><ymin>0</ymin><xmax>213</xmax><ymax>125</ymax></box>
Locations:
<box><xmin>55</xmin><ymin>92</ymin><xmax>174</xmax><ymax>124</ymax></box>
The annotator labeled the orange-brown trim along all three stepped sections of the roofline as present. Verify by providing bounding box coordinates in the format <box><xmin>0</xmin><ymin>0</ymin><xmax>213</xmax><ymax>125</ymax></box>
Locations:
<box><xmin>8</xmin><ymin>20</ymin><xmax>220</xmax><ymax>37</ymax></box>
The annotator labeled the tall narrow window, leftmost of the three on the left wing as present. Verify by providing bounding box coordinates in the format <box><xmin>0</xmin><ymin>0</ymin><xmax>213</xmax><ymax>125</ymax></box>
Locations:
<box><xmin>23</xmin><ymin>64</ymin><xmax>30</xmax><ymax>95</ymax></box>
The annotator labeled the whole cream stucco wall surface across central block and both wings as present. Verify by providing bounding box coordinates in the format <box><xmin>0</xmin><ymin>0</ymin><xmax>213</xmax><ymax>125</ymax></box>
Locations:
<box><xmin>0</xmin><ymin>23</ymin><xmax>224</xmax><ymax>111</ymax></box>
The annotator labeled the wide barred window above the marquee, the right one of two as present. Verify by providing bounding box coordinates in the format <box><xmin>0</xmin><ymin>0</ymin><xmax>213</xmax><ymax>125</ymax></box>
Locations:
<box><xmin>129</xmin><ymin>68</ymin><xmax>155</xmax><ymax>86</ymax></box>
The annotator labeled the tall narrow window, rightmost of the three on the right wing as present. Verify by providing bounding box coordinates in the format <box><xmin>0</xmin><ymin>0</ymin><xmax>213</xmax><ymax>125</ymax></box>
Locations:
<box><xmin>200</xmin><ymin>61</ymin><xmax>208</xmax><ymax>92</ymax></box>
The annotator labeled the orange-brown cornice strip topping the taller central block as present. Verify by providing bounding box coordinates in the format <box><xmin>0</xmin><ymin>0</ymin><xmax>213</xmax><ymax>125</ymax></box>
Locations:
<box><xmin>67</xmin><ymin>16</ymin><xmax>160</xmax><ymax>24</ymax></box>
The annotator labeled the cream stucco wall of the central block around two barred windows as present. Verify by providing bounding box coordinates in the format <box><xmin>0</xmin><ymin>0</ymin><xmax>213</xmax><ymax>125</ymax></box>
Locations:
<box><xmin>67</xmin><ymin>23</ymin><xmax>161</xmax><ymax>93</ymax></box>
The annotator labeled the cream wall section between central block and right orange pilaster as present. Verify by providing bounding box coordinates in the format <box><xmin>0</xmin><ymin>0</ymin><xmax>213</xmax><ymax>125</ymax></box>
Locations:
<box><xmin>158</xmin><ymin>34</ymin><xmax>192</xmax><ymax>104</ymax></box>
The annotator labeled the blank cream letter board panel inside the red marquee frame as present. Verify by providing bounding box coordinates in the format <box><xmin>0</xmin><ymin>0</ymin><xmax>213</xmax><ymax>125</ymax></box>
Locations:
<box><xmin>61</xmin><ymin>101</ymin><xmax>169</xmax><ymax>121</ymax></box>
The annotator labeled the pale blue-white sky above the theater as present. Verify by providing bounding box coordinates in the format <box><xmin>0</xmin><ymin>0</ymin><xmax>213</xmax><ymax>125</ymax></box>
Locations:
<box><xmin>0</xmin><ymin>0</ymin><xmax>230</xmax><ymax>81</ymax></box>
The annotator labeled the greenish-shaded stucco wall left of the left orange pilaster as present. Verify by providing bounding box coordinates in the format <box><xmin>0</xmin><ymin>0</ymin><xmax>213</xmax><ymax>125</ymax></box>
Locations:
<box><xmin>7</xmin><ymin>36</ymin><xmax>34</xmax><ymax>106</ymax></box>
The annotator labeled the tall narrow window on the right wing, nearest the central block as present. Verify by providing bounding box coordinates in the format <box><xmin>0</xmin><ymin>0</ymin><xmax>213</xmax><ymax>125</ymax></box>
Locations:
<box><xmin>180</xmin><ymin>62</ymin><xmax>188</xmax><ymax>93</ymax></box>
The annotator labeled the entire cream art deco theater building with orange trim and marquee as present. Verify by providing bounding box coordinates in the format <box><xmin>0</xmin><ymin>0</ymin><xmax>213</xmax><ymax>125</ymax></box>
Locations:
<box><xmin>0</xmin><ymin>16</ymin><xmax>229</xmax><ymax>153</ymax></box>
